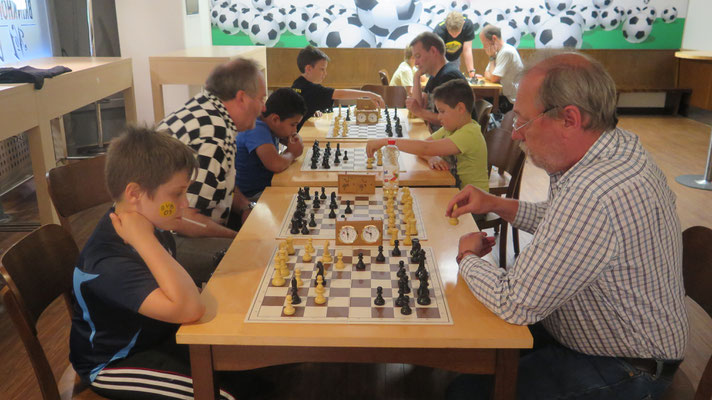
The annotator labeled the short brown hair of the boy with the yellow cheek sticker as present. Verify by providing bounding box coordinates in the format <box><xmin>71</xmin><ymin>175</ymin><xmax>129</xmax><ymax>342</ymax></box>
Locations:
<box><xmin>104</xmin><ymin>126</ymin><xmax>198</xmax><ymax>201</ymax></box>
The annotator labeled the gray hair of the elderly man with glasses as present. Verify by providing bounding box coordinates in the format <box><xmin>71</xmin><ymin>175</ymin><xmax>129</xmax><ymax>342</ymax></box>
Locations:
<box><xmin>523</xmin><ymin>51</ymin><xmax>618</xmax><ymax>131</ymax></box>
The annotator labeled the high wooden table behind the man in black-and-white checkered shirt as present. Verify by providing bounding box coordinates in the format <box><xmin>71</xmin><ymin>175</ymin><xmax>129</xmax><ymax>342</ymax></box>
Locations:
<box><xmin>148</xmin><ymin>46</ymin><xmax>268</xmax><ymax>122</ymax></box>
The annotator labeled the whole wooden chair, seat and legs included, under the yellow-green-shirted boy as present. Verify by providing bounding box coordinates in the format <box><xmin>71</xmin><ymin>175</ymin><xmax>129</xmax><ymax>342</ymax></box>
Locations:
<box><xmin>477</xmin><ymin>112</ymin><xmax>526</xmax><ymax>268</ymax></box>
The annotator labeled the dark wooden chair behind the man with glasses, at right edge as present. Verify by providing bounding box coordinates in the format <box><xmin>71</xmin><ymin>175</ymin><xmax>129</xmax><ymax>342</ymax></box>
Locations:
<box><xmin>682</xmin><ymin>226</ymin><xmax>712</xmax><ymax>400</ymax></box>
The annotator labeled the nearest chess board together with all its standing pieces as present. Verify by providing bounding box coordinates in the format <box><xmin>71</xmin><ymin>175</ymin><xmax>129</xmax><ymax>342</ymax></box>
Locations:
<box><xmin>245</xmin><ymin>239</ymin><xmax>452</xmax><ymax>325</ymax></box>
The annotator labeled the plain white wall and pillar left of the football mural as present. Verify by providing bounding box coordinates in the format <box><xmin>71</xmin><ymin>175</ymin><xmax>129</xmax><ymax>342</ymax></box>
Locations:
<box><xmin>116</xmin><ymin>0</ymin><xmax>211</xmax><ymax>125</ymax></box>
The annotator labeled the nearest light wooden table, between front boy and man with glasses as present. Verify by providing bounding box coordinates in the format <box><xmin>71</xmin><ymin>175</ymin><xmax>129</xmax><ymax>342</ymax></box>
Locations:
<box><xmin>176</xmin><ymin>187</ymin><xmax>532</xmax><ymax>399</ymax></box>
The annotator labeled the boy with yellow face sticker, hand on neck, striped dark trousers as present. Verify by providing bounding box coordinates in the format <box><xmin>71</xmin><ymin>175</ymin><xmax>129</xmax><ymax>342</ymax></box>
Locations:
<box><xmin>69</xmin><ymin>128</ymin><xmax>248</xmax><ymax>399</ymax></box>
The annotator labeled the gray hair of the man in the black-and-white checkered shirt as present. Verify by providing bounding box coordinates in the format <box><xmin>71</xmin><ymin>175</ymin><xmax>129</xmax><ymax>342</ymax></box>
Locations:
<box><xmin>205</xmin><ymin>58</ymin><xmax>261</xmax><ymax>101</ymax></box>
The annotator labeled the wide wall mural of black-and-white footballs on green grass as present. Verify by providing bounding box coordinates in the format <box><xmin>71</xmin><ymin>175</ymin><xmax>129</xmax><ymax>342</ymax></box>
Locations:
<box><xmin>210</xmin><ymin>0</ymin><xmax>688</xmax><ymax>49</ymax></box>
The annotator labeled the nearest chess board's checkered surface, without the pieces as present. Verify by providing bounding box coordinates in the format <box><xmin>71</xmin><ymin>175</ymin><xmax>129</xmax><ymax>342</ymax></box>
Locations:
<box><xmin>245</xmin><ymin>244</ymin><xmax>453</xmax><ymax>325</ymax></box>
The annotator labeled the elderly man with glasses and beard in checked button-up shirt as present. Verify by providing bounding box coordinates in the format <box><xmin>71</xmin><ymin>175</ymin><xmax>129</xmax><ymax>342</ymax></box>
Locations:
<box><xmin>446</xmin><ymin>53</ymin><xmax>688</xmax><ymax>399</ymax></box>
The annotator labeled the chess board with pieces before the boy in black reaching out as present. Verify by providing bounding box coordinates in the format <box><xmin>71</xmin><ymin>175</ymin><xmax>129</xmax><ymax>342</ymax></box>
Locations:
<box><xmin>327</xmin><ymin>107</ymin><xmax>408</xmax><ymax>140</ymax></box>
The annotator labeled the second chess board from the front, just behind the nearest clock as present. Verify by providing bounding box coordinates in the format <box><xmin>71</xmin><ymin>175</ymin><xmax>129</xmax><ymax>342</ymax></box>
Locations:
<box><xmin>277</xmin><ymin>188</ymin><xmax>428</xmax><ymax>242</ymax></box>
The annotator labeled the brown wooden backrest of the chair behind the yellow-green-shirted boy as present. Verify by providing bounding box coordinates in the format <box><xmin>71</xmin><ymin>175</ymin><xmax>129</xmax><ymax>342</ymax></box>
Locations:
<box><xmin>485</xmin><ymin>111</ymin><xmax>526</xmax><ymax>198</ymax></box>
